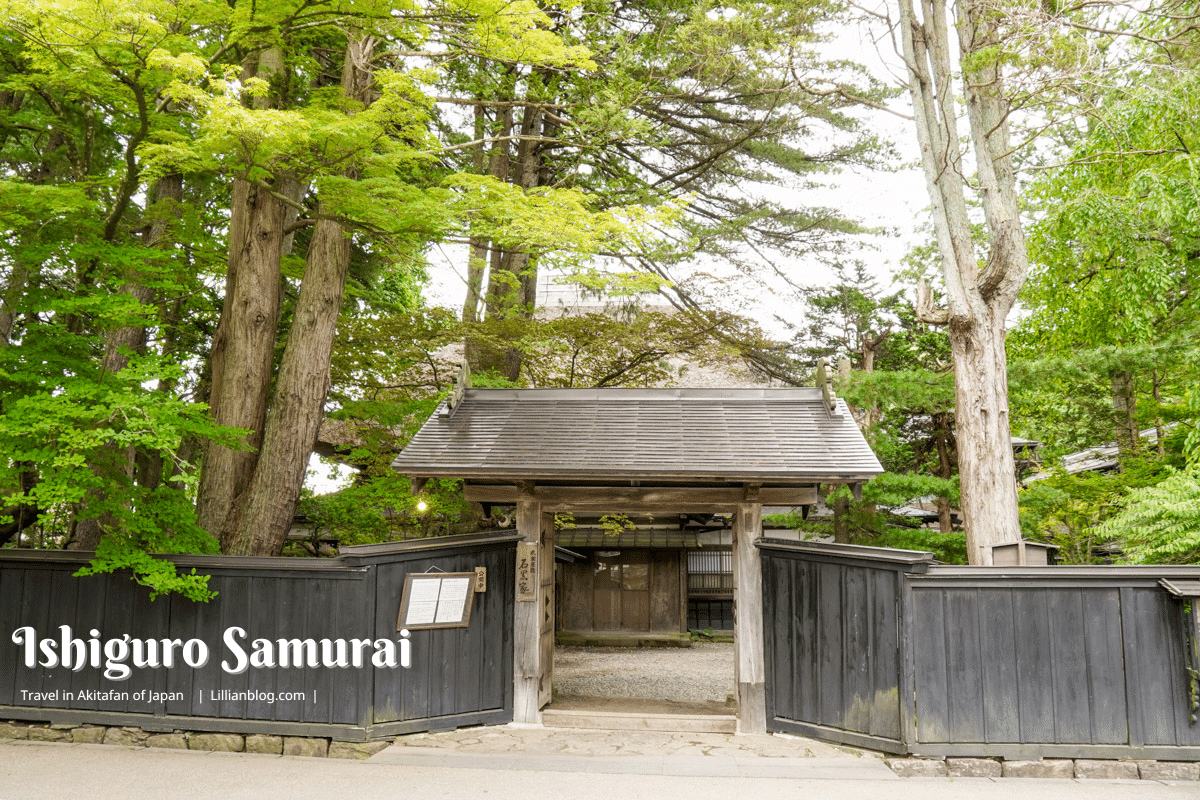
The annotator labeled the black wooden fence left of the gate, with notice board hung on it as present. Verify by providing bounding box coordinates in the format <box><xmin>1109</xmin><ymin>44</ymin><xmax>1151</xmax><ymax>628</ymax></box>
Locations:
<box><xmin>0</xmin><ymin>534</ymin><xmax>520</xmax><ymax>740</ymax></box>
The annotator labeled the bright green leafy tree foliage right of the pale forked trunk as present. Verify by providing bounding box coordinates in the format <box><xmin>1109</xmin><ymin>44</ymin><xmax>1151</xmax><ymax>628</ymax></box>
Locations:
<box><xmin>1009</xmin><ymin>67</ymin><xmax>1200</xmax><ymax>465</ymax></box>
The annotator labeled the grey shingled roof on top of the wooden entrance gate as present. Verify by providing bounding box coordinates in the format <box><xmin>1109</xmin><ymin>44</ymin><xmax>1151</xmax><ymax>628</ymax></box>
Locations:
<box><xmin>392</xmin><ymin>387</ymin><xmax>883</xmax><ymax>486</ymax></box>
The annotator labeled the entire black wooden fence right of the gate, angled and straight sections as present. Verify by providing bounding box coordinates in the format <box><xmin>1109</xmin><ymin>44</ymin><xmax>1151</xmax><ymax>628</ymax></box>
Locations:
<box><xmin>761</xmin><ymin>540</ymin><xmax>1200</xmax><ymax>760</ymax></box>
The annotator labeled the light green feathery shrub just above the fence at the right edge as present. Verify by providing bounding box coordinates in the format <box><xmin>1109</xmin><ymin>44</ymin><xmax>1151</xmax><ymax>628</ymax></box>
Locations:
<box><xmin>1098</xmin><ymin>468</ymin><xmax>1200</xmax><ymax>564</ymax></box>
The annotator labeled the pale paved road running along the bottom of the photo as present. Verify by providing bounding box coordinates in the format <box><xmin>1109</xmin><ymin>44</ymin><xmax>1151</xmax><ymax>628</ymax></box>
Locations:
<box><xmin>0</xmin><ymin>740</ymin><xmax>1200</xmax><ymax>800</ymax></box>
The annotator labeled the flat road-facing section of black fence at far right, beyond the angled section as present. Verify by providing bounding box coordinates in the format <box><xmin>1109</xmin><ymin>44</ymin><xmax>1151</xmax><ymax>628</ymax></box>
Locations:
<box><xmin>907</xmin><ymin>567</ymin><xmax>1200</xmax><ymax>759</ymax></box>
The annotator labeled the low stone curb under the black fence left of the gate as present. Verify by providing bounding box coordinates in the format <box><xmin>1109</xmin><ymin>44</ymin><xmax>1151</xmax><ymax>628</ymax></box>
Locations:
<box><xmin>0</xmin><ymin>722</ymin><xmax>392</xmax><ymax>759</ymax></box>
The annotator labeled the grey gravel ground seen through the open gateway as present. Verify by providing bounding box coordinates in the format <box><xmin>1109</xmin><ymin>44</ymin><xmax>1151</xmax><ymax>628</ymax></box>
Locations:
<box><xmin>554</xmin><ymin>642</ymin><xmax>737</xmax><ymax>705</ymax></box>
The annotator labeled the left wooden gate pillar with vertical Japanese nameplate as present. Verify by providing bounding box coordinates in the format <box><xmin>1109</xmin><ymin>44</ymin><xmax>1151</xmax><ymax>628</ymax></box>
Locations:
<box><xmin>512</xmin><ymin>489</ymin><xmax>554</xmax><ymax>724</ymax></box>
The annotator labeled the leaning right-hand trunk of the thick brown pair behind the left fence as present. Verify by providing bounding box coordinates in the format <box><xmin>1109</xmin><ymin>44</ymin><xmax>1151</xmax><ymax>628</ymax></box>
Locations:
<box><xmin>222</xmin><ymin>37</ymin><xmax>376</xmax><ymax>555</ymax></box>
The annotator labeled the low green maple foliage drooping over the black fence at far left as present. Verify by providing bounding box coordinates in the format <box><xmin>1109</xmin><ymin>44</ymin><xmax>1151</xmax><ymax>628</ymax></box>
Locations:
<box><xmin>0</xmin><ymin>321</ymin><xmax>242</xmax><ymax>600</ymax></box>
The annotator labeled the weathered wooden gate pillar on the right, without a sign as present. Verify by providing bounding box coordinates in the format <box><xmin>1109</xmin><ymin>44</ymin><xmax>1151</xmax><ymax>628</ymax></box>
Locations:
<box><xmin>733</xmin><ymin>503</ymin><xmax>767</xmax><ymax>733</ymax></box>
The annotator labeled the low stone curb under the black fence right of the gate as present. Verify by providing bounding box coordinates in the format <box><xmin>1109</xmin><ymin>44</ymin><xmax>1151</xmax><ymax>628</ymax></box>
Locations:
<box><xmin>883</xmin><ymin>758</ymin><xmax>1200</xmax><ymax>781</ymax></box>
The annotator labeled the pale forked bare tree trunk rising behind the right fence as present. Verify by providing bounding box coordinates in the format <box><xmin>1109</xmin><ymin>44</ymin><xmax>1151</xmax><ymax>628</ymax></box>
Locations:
<box><xmin>899</xmin><ymin>0</ymin><xmax>1028</xmax><ymax>564</ymax></box>
